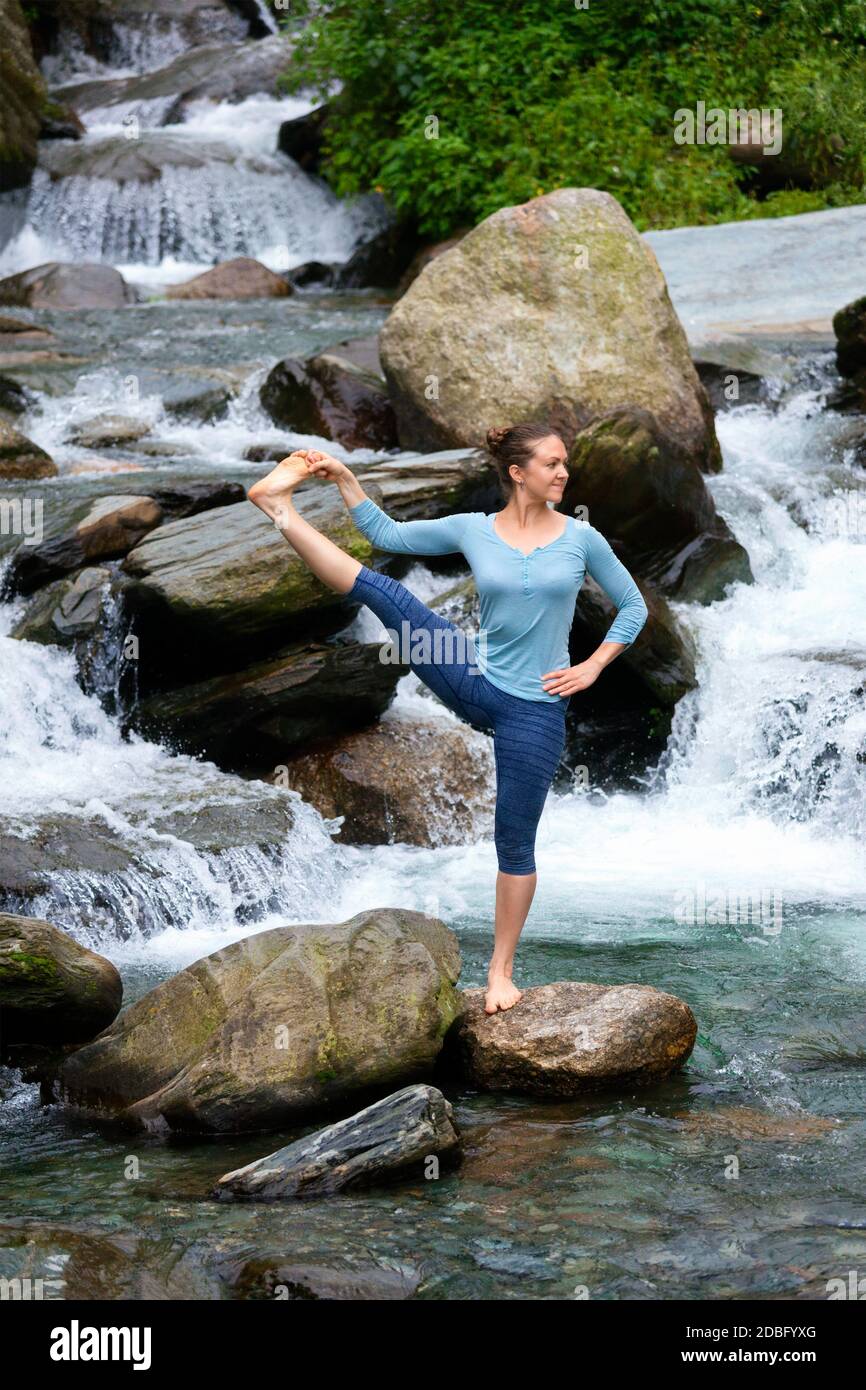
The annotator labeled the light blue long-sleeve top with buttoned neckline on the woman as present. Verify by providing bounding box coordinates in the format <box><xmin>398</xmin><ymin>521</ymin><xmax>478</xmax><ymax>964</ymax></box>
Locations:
<box><xmin>349</xmin><ymin>498</ymin><xmax>646</xmax><ymax>703</ymax></box>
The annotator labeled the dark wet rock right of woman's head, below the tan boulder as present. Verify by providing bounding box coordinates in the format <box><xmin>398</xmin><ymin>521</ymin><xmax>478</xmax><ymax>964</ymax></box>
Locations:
<box><xmin>562</xmin><ymin>407</ymin><xmax>752</xmax><ymax>602</ymax></box>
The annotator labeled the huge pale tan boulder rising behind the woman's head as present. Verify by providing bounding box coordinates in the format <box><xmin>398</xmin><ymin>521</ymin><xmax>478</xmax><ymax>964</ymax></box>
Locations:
<box><xmin>379</xmin><ymin>188</ymin><xmax>720</xmax><ymax>470</ymax></box>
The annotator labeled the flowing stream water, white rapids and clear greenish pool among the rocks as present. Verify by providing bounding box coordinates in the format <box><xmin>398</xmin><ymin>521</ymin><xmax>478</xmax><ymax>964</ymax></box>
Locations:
<box><xmin>0</xmin><ymin>10</ymin><xmax>866</xmax><ymax>1298</ymax></box>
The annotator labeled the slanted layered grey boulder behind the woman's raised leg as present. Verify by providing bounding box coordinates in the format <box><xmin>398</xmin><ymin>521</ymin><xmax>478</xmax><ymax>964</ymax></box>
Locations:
<box><xmin>124</xmin><ymin>450</ymin><xmax>495</xmax><ymax>695</ymax></box>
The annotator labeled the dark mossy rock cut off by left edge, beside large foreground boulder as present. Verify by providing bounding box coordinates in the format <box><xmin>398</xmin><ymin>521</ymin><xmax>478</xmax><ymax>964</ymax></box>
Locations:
<box><xmin>0</xmin><ymin>913</ymin><xmax>124</xmax><ymax>1056</ymax></box>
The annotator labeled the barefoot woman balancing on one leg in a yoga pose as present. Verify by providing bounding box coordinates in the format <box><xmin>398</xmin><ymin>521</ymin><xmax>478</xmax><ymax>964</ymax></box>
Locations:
<box><xmin>247</xmin><ymin>424</ymin><xmax>646</xmax><ymax>1013</ymax></box>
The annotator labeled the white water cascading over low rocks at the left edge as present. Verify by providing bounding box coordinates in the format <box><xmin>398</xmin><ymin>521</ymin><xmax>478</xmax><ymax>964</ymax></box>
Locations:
<box><xmin>0</xmin><ymin>583</ymin><xmax>355</xmax><ymax>949</ymax></box>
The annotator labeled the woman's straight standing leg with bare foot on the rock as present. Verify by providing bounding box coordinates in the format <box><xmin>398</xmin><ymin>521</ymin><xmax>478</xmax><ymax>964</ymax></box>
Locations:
<box><xmin>484</xmin><ymin>695</ymin><xmax>566</xmax><ymax>1013</ymax></box>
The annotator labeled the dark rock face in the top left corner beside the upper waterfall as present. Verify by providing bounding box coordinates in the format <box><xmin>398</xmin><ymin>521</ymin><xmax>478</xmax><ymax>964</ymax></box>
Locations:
<box><xmin>0</xmin><ymin>0</ymin><xmax>44</xmax><ymax>190</ymax></box>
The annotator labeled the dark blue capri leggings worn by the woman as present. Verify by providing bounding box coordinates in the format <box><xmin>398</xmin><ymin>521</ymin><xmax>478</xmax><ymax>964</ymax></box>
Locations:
<box><xmin>348</xmin><ymin>564</ymin><xmax>569</xmax><ymax>874</ymax></box>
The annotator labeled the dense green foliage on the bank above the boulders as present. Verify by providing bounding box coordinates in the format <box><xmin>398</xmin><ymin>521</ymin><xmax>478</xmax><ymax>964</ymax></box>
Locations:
<box><xmin>285</xmin><ymin>0</ymin><xmax>866</xmax><ymax>236</ymax></box>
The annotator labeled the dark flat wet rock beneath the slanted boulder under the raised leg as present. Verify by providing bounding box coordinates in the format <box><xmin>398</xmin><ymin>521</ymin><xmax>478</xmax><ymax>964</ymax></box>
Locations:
<box><xmin>132</xmin><ymin>642</ymin><xmax>403</xmax><ymax>769</ymax></box>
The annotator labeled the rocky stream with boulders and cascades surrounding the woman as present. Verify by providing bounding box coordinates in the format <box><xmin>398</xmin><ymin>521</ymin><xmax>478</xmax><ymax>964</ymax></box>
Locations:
<box><xmin>0</xmin><ymin>0</ymin><xmax>866</xmax><ymax>1298</ymax></box>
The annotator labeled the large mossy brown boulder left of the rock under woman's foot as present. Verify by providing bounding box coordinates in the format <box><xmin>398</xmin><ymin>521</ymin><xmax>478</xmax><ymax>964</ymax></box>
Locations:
<box><xmin>56</xmin><ymin>909</ymin><xmax>460</xmax><ymax>1133</ymax></box>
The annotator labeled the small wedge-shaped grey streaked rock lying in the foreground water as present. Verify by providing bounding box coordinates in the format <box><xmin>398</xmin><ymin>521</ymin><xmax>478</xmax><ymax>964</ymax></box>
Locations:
<box><xmin>214</xmin><ymin>1086</ymin><xmax>460</xmax><ymax>1201</ymax></box>
